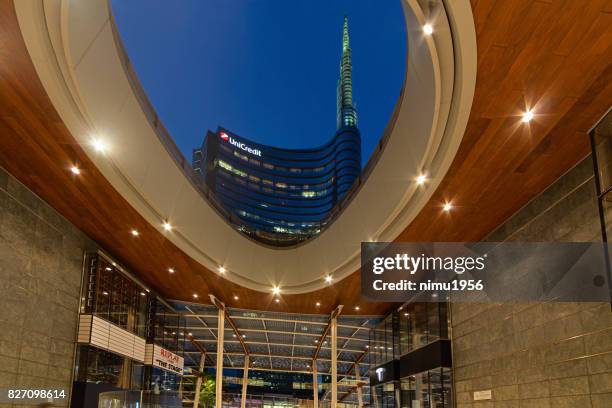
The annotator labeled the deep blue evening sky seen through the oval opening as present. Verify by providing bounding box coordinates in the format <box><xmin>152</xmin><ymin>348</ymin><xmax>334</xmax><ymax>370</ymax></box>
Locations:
<box><xmin>112</xmin><ymin>0</ymin><xmax>406</xmax><ymax>164</ymax></box>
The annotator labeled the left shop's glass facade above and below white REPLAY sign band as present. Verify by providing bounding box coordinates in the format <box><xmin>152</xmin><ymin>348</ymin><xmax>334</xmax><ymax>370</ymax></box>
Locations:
<box><xmin>72</xmin><ymin>253</ymin><xmax>185</xmax><ymax>407</ymax></box>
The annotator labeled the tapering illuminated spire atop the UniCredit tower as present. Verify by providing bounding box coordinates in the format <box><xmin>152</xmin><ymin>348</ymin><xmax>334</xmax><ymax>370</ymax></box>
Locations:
<box><xmin>337</xmin><ymin>15</ymin><xmax>357</xmax><ymax>129</ymax></box>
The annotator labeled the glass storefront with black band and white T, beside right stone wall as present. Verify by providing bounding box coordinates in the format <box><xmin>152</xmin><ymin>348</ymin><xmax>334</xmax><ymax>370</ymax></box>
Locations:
<box><xmin>369</xmin><ymin>303</ymin><xmax>453</xmax><ymax>408</ymax></box>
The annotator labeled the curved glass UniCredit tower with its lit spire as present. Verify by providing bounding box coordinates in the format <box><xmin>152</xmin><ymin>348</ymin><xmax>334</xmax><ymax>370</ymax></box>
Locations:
<box><xmin>193</xmin><ymin>17</ymin><xmax>361</xmax><ymax>246</ymax></box>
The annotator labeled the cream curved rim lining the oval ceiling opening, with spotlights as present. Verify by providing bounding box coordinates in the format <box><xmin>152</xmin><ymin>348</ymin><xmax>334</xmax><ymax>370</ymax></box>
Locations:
<box><xmin>15</xmin><ymin>0</ymin><xmax>476</xmax><ymax>293</ymax></box>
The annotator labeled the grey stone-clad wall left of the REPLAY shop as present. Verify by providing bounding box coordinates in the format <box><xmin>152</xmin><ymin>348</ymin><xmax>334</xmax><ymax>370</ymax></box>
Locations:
<box><xmin>0</xmin><ymin>168</ymin><xmax>95</xmax><ymax>407</ymax></box>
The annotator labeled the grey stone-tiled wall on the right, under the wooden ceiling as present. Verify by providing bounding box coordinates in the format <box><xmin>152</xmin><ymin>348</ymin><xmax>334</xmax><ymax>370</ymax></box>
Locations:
<box><xmin>452</xmin><ymin>157</ymin><xmax>612</xmax><ymax>408</ymax></box>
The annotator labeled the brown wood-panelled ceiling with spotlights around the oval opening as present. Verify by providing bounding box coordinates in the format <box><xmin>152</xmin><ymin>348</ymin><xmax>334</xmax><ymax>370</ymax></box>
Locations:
<box><xmin>0</xmin><ymin>0</ymin><xmax>612</xmax><ymax>314</ymax></box>
